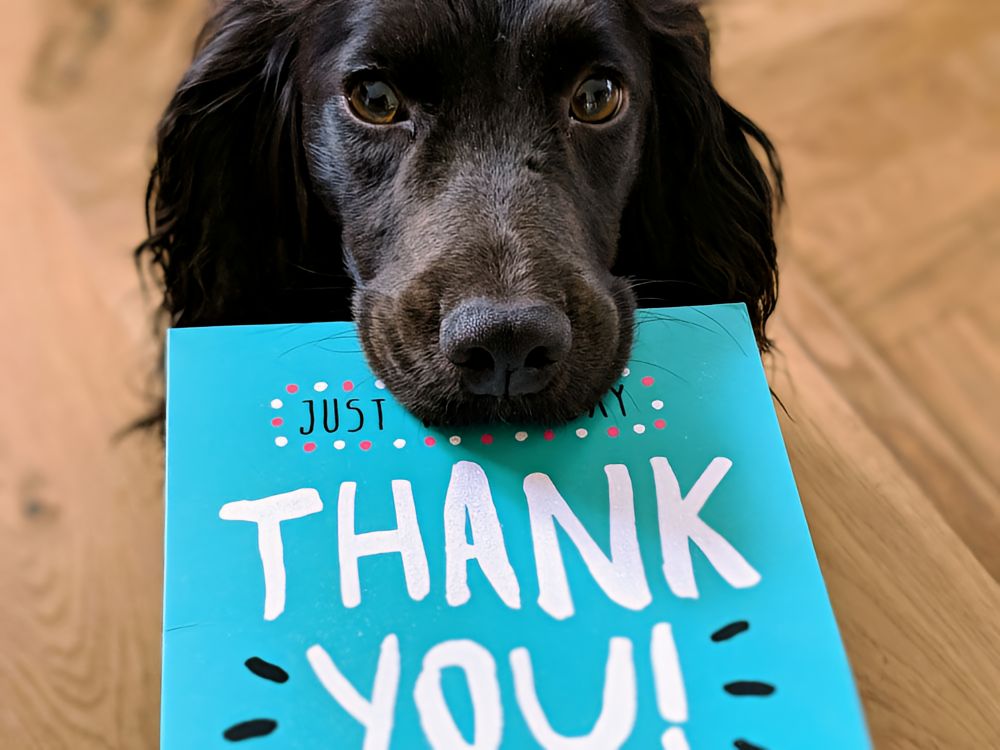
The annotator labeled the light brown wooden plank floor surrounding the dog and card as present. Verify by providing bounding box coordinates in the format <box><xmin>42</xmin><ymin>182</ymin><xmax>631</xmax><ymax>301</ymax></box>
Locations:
<box><xmin>0</xmin><ymin>0</ymin><xmax>1000</xmax><ymax>750</ymax></box>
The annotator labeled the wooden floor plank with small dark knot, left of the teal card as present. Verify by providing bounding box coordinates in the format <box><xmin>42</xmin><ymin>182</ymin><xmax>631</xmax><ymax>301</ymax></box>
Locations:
<box><xmin>0</xmin><ymin>7</ymin><xmax>162</xmax><ymax>750</ymax></box>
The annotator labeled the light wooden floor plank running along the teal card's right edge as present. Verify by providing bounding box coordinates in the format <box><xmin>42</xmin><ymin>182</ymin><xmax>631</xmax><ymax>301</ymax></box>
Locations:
<box><xmin>772</xmin><ymin>314</ymin><xmax>1000</xmax><ymax>750</ymax></box>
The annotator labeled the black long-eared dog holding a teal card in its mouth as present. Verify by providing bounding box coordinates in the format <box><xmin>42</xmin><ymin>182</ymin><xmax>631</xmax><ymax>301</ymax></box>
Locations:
<box><xmin>138</xmin><ymin>0</ymin><xmax>781</xmax><ymax>422</ymax></box>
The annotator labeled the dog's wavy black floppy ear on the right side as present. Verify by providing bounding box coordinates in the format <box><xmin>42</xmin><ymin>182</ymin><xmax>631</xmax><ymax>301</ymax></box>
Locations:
<box><xmin>614</xmin><ymin>0</ymin><xmax>783</xmax><ymax>350</ymax></box>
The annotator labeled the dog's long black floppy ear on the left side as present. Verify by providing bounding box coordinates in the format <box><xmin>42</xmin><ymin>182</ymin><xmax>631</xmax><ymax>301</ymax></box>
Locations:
<box><xmin>136</xmin><ymin>0</ymin><xmax>350</xmax><ymax>326</ymax></box>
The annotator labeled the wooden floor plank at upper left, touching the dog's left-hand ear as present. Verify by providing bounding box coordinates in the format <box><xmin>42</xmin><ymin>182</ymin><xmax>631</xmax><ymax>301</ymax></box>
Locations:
<box><xmin>18</xmin><ymin>0</ymin><xmax>208</xmax><ymax>342</ymax></box>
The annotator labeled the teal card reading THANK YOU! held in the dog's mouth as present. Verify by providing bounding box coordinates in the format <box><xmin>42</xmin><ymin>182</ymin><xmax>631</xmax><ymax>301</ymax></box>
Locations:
<box><xmin>162</xmin><ymin>305</ymin><xmax>870</xmax><ymax>750</ymax></box>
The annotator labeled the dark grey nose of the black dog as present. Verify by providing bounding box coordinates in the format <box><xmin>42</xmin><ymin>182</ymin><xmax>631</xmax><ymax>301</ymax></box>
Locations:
<box><xmin>441</xmin><ymin>299</ymin><xmax>572</xmax><ymax>396</ymax></box>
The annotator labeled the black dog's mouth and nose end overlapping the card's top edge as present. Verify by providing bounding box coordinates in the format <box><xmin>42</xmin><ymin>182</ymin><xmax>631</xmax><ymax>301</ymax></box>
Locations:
<box><xmin>357</xmin><ymin>282</ymin><xmax>634</xmax><ymax>426</ymax></box>
